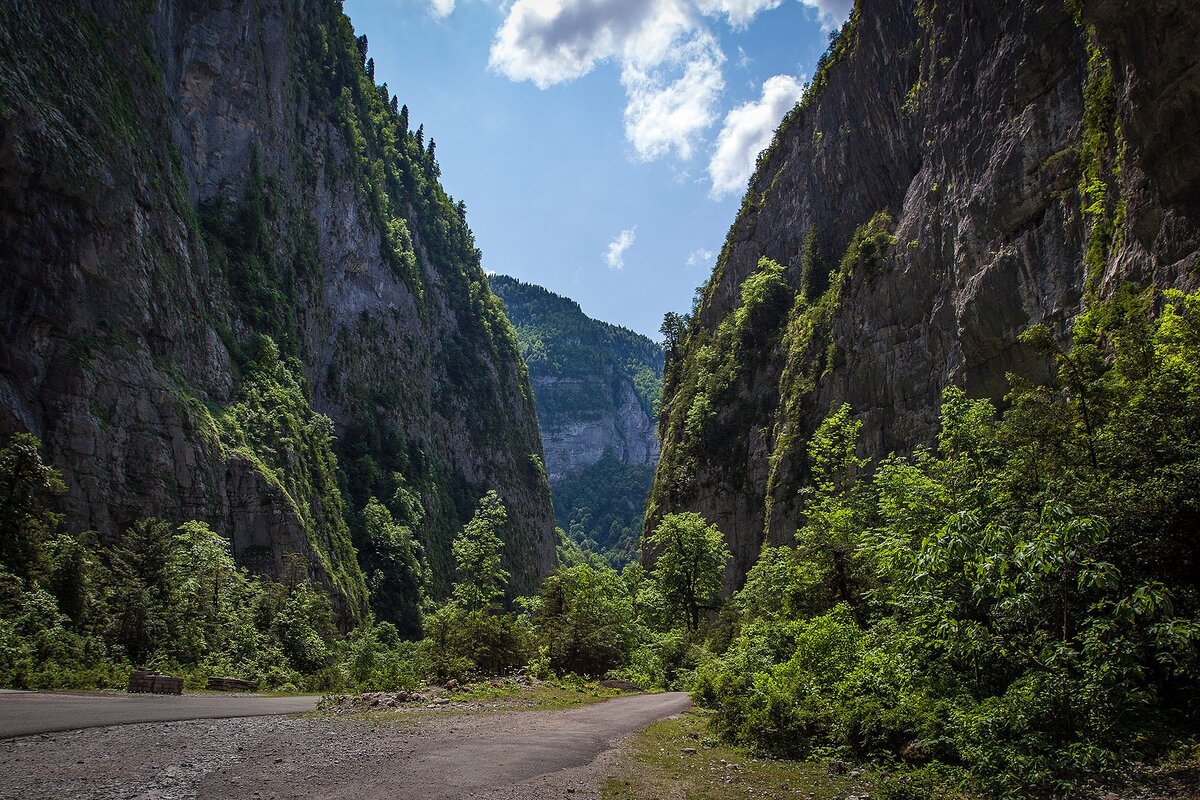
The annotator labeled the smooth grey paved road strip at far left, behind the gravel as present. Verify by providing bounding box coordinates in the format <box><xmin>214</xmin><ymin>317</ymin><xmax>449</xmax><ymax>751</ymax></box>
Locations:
<box><xmin>0</xmin><ymin>692</ymin><xmax>319</xmax><ymax>739</ymax></box>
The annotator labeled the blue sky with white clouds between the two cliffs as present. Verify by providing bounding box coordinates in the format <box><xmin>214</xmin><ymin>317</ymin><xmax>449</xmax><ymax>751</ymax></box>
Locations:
<box><xmin>344</xmin><ymin>0</ymin><xmax>852</xmax><ymax>338</ymax></box>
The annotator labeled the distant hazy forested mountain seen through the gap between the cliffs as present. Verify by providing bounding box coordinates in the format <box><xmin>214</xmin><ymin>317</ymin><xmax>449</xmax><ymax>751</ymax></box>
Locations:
<box><xmin>491</xmin><ymin>275</ymin><xmax>662</xmax><ymax>564</ymax></box>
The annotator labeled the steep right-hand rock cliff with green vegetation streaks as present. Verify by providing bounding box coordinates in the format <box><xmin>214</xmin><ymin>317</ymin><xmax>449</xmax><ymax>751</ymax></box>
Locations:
<box><xmin>647</xmin><ymin>0</ymin><xmax>1200</xmax><ymax>585</ymax></box>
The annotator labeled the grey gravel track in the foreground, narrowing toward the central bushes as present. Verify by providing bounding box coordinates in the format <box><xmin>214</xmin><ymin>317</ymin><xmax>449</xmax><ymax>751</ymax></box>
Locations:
<box><xmin>0</xmin><ymin>693</ymin><xmax>689</xmax><ymax>800</ymax></box>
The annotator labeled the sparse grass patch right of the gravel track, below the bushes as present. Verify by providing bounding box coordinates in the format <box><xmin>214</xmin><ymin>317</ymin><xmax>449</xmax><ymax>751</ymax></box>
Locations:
<box><xmin>601</xmin><ymin>711</ymin><xmax>875</xmax><ymax>800</ymax></box>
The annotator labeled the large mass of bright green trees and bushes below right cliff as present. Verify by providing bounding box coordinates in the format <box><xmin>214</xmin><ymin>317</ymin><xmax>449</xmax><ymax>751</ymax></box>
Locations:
<box><xmin>696</xmin><ymin>291</ymin><xmax>1200</xmax><ymax>798</ymax></box>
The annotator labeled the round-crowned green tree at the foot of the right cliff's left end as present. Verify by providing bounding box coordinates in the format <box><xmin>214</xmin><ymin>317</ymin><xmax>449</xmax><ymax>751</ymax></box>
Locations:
<box><xmin>646</xmin><ymin>511</ymin><xmax>732</xmax><ymax>631</ymax></box>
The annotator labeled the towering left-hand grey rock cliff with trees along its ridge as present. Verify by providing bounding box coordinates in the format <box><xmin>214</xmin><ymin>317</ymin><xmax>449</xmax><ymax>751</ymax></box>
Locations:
<box><xmin>0</xmin><ymin>0</ymin><xmax>554</xmax><ymax>616</ymax></box>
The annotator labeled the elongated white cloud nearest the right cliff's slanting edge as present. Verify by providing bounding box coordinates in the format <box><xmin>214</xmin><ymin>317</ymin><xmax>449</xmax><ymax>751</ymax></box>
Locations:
<box><xmin>708</xmin><ymin>76</ymin><xmax>804</xmax><ymax>198</ymax></box>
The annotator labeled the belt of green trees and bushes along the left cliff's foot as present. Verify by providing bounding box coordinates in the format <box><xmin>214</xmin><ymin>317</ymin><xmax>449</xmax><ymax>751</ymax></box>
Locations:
<box><xmin>0</xmin><ymin>434</ymin><xmax>724</xmax><ymax>691</ymax></box>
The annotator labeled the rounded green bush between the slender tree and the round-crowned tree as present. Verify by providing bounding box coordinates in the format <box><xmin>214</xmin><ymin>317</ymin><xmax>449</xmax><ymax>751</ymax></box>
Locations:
<box><xmin>535</xmin><ymin>565</ymin><xmax>638</xmax><ymax>675</ymax></box>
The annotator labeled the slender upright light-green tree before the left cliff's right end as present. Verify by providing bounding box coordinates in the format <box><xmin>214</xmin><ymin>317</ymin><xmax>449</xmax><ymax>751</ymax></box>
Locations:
<box><xmin>454</xmin><ymin>491</ymin><xmax>509</xmax><ymax>612</ymax></box>
